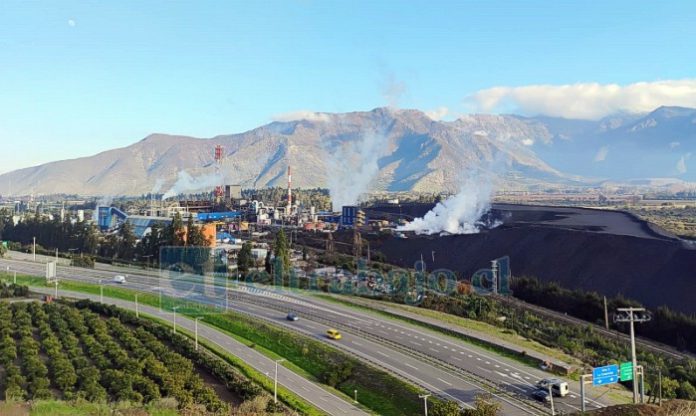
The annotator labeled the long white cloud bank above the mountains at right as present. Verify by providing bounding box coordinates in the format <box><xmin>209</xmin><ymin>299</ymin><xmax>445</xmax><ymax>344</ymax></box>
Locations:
<box><xmin>467</xmin><ymin>79</ymin><xmax>696</xmax><ymax>120</ymax></box>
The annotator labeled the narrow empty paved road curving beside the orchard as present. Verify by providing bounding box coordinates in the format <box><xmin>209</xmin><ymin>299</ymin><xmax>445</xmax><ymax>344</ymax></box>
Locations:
<box><xmin>28</xmin><ymin>288</ymin><xmax>369</xmax><ymax>415</ymax></box>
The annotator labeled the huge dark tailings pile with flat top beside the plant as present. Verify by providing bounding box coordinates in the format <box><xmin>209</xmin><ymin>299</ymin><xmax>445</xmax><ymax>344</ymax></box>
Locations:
<box><xmin>368</xmin><ymin>204</ymin><xmax>696</xmax><ymax>313</ymax></box>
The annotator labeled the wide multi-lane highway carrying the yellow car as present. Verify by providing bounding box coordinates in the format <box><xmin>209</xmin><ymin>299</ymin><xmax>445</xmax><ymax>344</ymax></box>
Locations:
<box><xmin>0</xmin><ymin>254</ymin><xmax>620</xmax><ymax>415</ymax></box>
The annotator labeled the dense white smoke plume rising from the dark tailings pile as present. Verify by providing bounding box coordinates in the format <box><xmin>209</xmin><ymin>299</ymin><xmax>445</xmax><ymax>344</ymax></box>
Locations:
<box><xmin>397</xmin><ymin>154</ymin><xmax>502</xmax><ymax>235</ymax></box>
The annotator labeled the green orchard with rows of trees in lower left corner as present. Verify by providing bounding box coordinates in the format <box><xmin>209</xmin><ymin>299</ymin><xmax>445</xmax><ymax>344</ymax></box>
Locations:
<box><xmin>0</xmin><ymin>302</ymin><xmax>229</xmax><ymax>413</ymax></box>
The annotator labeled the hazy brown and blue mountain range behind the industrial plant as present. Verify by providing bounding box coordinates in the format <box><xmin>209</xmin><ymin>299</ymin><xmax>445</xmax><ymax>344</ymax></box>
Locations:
<box><xmin>0</xmin><ymin>107</ymin><xmax>696</xmax><ymax>195</ymax></box>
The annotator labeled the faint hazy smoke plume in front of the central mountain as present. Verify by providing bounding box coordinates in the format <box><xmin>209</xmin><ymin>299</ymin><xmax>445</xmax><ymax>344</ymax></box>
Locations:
<box><xmin>327</xmin><ymin>133</ymin><xmax>387</xmax><ymax>210</ymax></box>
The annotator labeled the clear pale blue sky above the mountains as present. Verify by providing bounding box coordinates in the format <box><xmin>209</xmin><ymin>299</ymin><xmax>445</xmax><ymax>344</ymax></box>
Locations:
<box><xmin>0</xmin><ymin>0</ymin><xmax>696</xmax><ymax>172</ymax></box>
